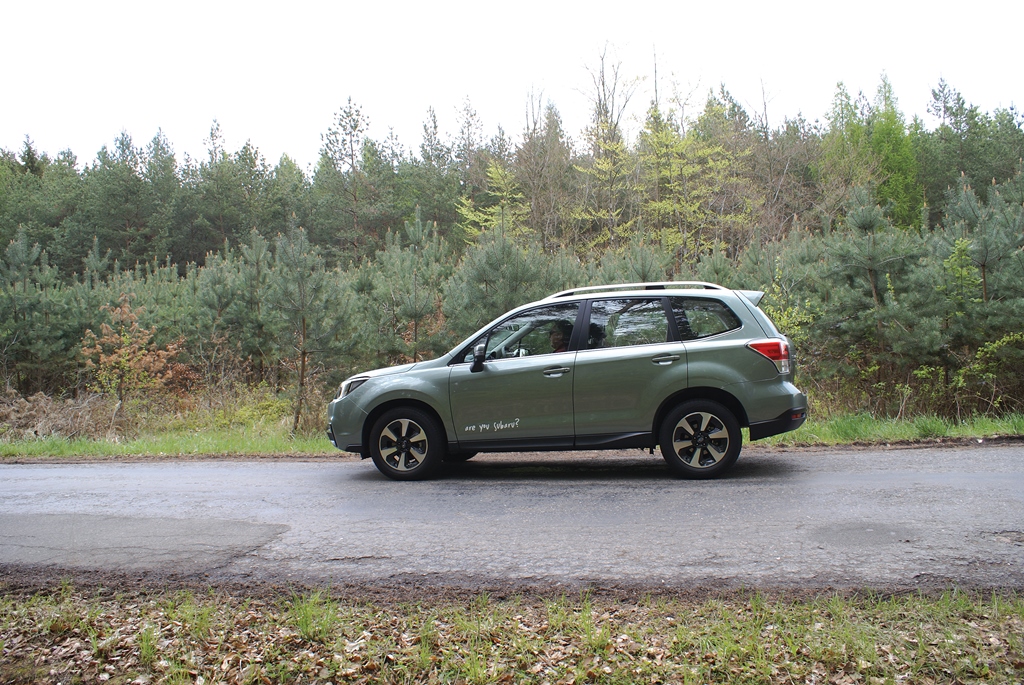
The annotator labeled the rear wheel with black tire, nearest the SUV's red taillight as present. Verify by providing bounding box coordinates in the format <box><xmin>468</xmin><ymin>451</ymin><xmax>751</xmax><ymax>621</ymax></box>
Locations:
<box><xmin>658</xmin><ymin>399</ymin><xmax>743</xmax><ymax>480</ymax></box>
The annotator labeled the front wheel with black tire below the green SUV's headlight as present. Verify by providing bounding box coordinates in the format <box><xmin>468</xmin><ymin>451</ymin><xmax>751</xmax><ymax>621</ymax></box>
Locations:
<box><xmin>370</xmin><ymin>406</ymin><xmax>446</xmax><ymax>480</ymax></box>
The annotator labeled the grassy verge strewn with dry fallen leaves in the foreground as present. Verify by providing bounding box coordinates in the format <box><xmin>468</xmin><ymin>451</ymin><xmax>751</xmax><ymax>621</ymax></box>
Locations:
<box><xmin>0</xmin><ymin>587</ymin><xmax>1024</xmax><ymax>685</ymax></box>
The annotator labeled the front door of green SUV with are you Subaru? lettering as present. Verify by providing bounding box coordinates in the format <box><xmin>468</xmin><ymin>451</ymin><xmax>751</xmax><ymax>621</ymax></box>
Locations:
<box><xmin>449</xmin><ymin>302</ymin><xmax>580</xmax><ymax>449</ymax></box>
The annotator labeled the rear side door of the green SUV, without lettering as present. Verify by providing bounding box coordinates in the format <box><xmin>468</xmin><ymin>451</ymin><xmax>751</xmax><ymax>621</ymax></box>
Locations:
<box><xmin>572</xmin><ymin>297</ymin><xmax>686</xmax><ymax>446</ymax></box>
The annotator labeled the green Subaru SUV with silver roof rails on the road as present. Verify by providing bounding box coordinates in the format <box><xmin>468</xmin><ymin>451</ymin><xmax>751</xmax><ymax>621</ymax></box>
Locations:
<box><xmin>328</xmin><ymin>282</ymin><xmax>807</xmax><ymax>480</ymax></box>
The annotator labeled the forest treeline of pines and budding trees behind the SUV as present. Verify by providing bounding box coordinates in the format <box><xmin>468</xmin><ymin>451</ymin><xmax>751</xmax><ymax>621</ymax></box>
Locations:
<box><xmin>0</xmin><ymin>70</ymin><xmax>1024</xmax><ymax>424</ymax></box>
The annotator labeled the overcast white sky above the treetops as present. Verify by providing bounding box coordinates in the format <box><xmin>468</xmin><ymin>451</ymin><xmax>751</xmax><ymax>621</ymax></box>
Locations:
<box><xmin>0</xmin><ymin>0</ymin><xmax>1024</xmax><ymax>167</ymax></box>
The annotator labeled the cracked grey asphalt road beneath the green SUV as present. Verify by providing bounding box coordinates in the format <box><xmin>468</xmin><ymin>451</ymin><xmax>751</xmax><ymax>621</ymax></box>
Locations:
<box><xmin>0</xmin><ymin>444</ymin><xmax>1024</xmax><ymax>590</ymax></box>
